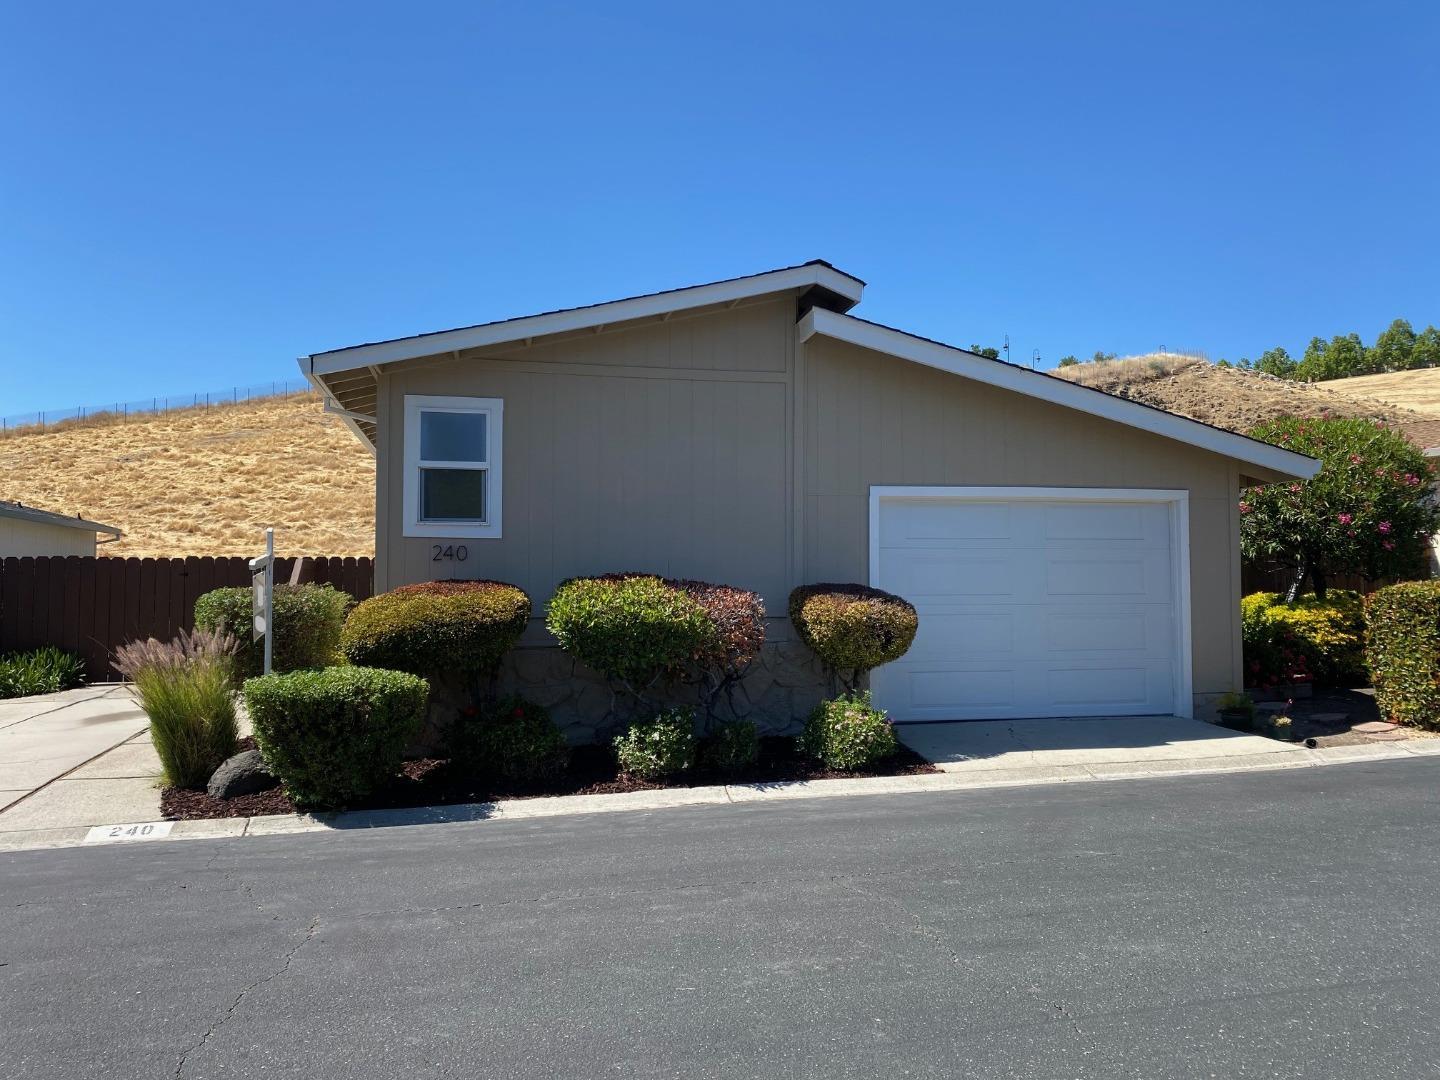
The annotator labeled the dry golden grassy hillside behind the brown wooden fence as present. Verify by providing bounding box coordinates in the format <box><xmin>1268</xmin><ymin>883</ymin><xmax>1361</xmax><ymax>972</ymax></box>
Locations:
<box><xmin>0</xmin><ymin>395</ymin><xmax>374</xmax><ymax>556</ymax></box>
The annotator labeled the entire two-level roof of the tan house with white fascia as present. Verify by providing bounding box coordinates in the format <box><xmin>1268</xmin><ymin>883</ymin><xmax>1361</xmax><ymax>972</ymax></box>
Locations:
<box><xmin>300</xmin><ymin>259</ymin><xmax>1319</xmax><ymax>480</ymax></box>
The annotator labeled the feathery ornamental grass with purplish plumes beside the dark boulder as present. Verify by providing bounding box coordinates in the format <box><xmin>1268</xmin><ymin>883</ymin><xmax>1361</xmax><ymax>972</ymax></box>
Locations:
<box><xmin>114</xmin><ymin>629</ymin><xmax>239</xmax><ymax>788</ymax></box>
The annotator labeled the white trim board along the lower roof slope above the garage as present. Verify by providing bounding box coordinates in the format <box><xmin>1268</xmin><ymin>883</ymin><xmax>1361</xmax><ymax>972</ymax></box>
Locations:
<box><xmin>798</xmin><ymin>308</ymin><xmax>1320</xmax><ymax>480</ymax></box>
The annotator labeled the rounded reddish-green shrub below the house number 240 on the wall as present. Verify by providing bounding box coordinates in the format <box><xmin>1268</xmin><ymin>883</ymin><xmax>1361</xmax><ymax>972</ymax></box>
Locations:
<box><xmin>340</xmin><ymin>580</ymin><xmax>530</xmax><ymax>677</ymax></box>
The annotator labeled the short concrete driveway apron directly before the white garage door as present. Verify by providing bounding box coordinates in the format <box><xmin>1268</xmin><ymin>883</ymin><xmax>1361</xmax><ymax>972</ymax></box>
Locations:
<box><xmin>896</xmin><ymin>716</ymin><xmax>1295</xmax><ymax>772</ymax></box>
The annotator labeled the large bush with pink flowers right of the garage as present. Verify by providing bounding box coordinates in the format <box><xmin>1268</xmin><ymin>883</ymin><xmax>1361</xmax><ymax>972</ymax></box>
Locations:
<box><xmin>1240</xmin><ymin>416</ymin><xmax>1440</xmax><ymax>599</ymax></box>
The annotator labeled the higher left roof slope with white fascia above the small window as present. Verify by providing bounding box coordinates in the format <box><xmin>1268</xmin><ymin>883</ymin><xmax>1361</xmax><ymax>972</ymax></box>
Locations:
<box><xmin>298</xmin><ymin>259</ymin><xmax>865</xmax><ymax>451</ymax></box>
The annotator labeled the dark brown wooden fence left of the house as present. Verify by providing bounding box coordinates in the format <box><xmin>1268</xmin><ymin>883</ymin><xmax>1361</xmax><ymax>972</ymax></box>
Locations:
<box><xmin>0</xmin><ymin>556</ymin><xmax>374</xmax><ymax>681</ymax></box>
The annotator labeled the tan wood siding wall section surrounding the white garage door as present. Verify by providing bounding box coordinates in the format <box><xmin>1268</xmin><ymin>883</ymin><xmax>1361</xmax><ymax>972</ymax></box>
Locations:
<box><xmin>799</xmin><ymin>338</ymin><xmax>1240</xmax><ymax>694</ymax></box>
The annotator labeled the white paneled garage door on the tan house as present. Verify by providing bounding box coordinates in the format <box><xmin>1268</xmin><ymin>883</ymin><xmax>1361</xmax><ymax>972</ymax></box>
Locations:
<box><xmin>871</xmin><ymin>492</ymin><xmax>1188</xmax><ymax>720</ymax></box>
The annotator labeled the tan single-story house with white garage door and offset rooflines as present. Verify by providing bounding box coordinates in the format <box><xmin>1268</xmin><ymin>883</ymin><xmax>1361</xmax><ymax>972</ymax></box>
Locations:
<box><xmin>300</xmin><ymin>261</ymin><xmax>1319</xmax><ymax>723</ymax></box>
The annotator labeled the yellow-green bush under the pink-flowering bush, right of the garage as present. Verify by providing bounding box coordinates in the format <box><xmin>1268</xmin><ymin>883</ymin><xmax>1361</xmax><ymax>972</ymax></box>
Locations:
<box><xmin>1240</xmin><ymin>589</ymin><xmax>1369</xmax><ymax>687</ymax></box>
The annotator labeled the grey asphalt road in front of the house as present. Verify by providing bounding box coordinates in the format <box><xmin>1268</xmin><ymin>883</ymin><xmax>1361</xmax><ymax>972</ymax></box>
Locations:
<box><xmin>0</xmin><ymin>760</ymin><xmax>1440</xmax><ymax>1080</ymax></box>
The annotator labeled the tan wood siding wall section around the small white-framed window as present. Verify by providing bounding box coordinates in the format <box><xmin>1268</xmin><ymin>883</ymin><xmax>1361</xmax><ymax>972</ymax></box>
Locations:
<box><xmin>376</xmin><ymin>300</ymin><xmax>793</xmax><ymax>611</ymax></box>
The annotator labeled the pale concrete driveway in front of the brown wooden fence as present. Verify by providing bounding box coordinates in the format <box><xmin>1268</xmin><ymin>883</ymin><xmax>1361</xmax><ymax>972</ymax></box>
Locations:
<box><xmin>0</xmin><ymin>684</ymin><xmax>160</xmax><ymax>832</ymax></box>
